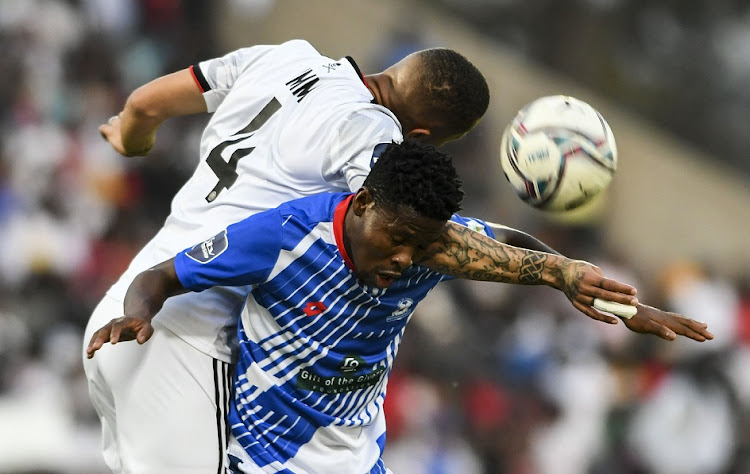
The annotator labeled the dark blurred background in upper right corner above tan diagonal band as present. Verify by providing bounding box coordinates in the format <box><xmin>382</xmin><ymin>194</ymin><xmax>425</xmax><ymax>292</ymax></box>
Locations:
<box><xmin>435</xmin><ymin>0</ymin><xmax>750</xmax><ymax>177</ymax></box>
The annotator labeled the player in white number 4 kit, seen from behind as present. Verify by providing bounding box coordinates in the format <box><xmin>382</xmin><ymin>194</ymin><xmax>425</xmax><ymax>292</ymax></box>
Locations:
<box><xmin>89</xmin><ymin>40</ymin><xmax>707</xmax><ymax>474</ymax></box>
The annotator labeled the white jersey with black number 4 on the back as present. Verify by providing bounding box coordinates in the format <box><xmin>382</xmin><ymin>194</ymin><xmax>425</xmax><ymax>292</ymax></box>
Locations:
<box><xmin>108</xmin><ymin>40</ymin><xmax>403</xmax><ymax>362</ymax></box>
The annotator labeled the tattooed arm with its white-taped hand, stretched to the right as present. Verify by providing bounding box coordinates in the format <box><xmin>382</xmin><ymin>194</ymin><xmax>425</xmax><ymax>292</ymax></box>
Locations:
<box><xmin>418</xmin><ymin>223</ymin><xmax>638</xmax><ymax>324</ymax></box>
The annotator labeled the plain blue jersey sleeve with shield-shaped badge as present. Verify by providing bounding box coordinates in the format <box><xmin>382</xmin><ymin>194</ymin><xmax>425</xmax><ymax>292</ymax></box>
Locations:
<box><xmin>174</xmin><ymin>209</ymin><xmax>283</xmax><ymax>291</ymax></box>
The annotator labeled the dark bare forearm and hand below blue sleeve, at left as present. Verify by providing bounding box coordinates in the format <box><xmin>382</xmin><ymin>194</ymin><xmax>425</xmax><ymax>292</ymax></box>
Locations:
<box><xmin>86</xmin><ymin>259</ymin><xmax>187</xmax><ymax>359</ymax></box>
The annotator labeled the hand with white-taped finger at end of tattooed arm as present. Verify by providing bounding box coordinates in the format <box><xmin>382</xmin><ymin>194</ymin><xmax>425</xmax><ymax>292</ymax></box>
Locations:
<box><xmin>558</xmin><ymin>260</ymin><xmax>638</xmax><ymax>324</ymax></box>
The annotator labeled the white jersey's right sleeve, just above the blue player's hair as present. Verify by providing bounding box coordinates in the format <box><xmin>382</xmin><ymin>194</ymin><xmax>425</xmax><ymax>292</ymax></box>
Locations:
<box><xmin>329</xmin><ymin>109</ymin><xmax>403</xmax><ymax>191</ymax></box>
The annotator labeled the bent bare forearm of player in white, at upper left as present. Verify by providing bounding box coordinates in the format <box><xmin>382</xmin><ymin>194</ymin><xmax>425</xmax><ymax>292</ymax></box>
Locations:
<box><xmin>99</xmin><ymin>69</ymin><xmax>207</xmax><ymax>156</ymax></box>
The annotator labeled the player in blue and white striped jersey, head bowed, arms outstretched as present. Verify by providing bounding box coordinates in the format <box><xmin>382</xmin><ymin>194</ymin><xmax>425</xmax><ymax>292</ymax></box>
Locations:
<box><xmin>87</xmin><ymin>141</ymin><xmax>700</xmax><ymax>474</ymax></box>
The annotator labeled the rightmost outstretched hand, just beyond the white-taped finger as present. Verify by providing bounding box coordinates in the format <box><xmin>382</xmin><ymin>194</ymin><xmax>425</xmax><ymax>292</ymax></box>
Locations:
<box><xmin>623</xmin><ymin>304</ymin><xmax>714</xmax><ymax>342</ymax></box>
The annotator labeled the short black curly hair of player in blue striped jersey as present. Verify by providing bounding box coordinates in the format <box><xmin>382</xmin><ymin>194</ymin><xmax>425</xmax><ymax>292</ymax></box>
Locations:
<box><xmin>363</xmin><ymin>140</ymin><xmax>464</xmax><ymax>221</ymax></box>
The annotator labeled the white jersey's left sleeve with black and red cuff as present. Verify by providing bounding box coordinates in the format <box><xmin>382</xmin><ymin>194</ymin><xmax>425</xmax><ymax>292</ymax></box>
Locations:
<box><xmin>190</xmin><ymin>45</ymin><xmax>278</xmax><ymax>112</ymax></box>
